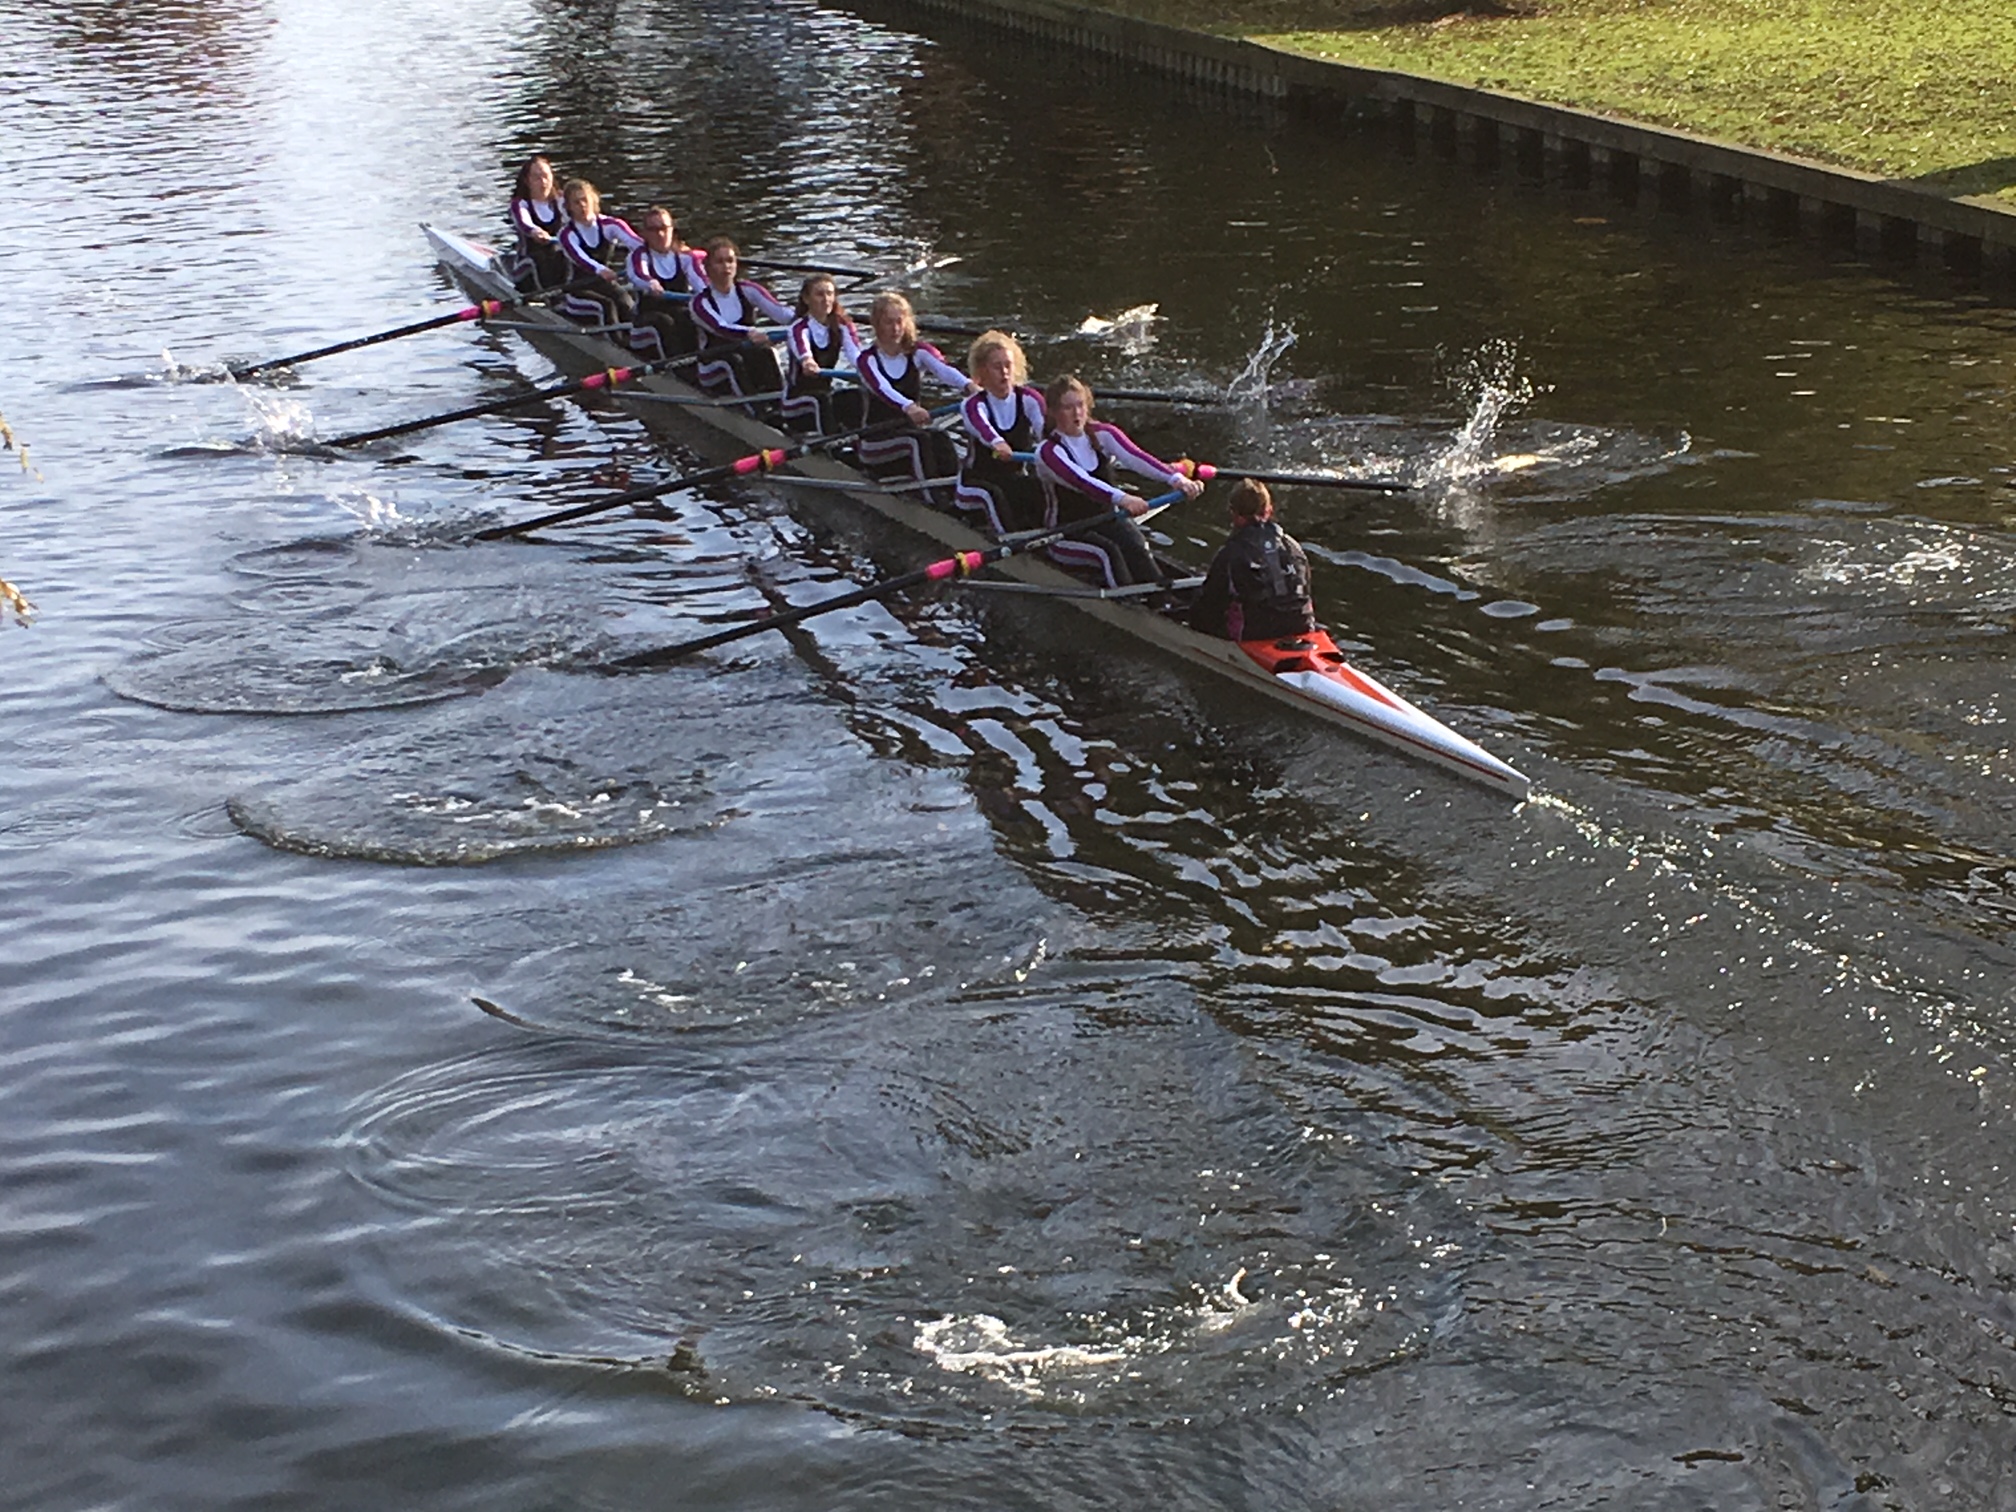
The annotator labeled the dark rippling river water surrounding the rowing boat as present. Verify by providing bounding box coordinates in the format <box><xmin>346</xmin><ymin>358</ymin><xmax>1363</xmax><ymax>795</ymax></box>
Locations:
<box><xmin>0</xmin><ymin>0</ymin><xmax>2016</xmax><ymax>1512</ymax></box>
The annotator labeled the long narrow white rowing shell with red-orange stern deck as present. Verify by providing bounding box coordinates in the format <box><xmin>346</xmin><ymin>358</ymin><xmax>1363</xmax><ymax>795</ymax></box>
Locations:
<box><xmin>421</xmin><ymin>226</ymin><xmax>1530</xmax><ymax>798</ymax></box>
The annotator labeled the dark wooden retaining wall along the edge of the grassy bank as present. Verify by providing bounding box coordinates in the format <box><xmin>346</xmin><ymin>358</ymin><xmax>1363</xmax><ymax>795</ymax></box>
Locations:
<box><xmin>879</xmin><ymin>0</ymin><xmax>2016</xmax><ymax>284</ymax></box>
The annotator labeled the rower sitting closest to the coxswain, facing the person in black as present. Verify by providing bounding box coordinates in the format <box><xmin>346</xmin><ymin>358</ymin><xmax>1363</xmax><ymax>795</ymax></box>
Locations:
<box><xmin>1036</xmin><ymin>377</ymin><xmax>1204</xmax><ymax>589</ymax></box>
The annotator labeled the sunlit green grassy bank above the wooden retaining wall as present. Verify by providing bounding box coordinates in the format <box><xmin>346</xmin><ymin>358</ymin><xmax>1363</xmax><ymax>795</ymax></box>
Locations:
<box><xmin>1101</xmin><ymin>0</ymin><xmax>2016</xmax><ymax>204</ymax></box>
